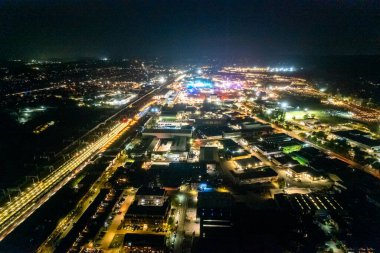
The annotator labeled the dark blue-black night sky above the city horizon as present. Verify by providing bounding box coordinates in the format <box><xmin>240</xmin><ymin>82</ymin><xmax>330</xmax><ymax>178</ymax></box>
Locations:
<box><xmin>0</xmin><ymin>0</ymin><xmax>380</xmax><ymax>58</ymax></box>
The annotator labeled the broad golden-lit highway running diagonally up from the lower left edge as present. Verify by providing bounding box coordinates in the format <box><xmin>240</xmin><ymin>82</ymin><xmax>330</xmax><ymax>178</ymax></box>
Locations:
<box><xmin>0</xmin><ymin>82</ymin><xmax>168</xmax><ymax>241</ymax></box>
